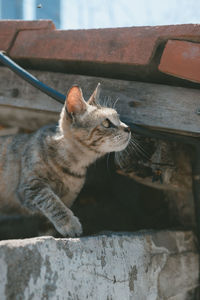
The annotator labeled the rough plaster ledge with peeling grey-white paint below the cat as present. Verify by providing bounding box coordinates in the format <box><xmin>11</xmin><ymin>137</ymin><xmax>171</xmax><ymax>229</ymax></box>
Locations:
<box><xmin>0</xmin><ymin>231</ymin><xmax>199</xmax><ymax>300</ymax></box>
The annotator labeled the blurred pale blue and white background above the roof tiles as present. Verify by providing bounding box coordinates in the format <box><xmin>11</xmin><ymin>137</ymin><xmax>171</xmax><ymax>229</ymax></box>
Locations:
<box><xmin>0</xmin><ymin>0</ymin><xmax>200</xmax><ymax>29</ymax></box>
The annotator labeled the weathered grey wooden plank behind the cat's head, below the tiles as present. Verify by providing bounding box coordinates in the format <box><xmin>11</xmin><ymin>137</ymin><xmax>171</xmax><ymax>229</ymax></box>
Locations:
<box><xmin>0</xmin><ymin>67</ymin><xmax>200</xmax><ymax>136</ymax></box>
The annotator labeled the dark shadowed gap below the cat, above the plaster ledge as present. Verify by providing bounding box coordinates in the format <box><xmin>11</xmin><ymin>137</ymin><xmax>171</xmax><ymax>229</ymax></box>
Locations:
<box><xmin>0</xmin><ymin>155</ymin><xmax>189</xmax><ymax>239</ymax></box>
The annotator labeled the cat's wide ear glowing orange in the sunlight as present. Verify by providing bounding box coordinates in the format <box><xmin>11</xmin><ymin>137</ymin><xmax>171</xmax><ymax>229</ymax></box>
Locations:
<box><xmin>65</xmin><ymin>85</ymin><xmax>87</xmax><ymax>115</ymax></box>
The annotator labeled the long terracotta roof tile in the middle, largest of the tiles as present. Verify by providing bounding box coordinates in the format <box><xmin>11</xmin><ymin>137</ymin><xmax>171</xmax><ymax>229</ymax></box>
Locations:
<box><xmin>10</xmin><ymin>25</ymin><xmax>200</xmax><ymax>65</ymax></box>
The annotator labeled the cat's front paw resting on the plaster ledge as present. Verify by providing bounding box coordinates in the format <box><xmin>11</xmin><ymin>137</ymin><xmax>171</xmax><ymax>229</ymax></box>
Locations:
<box><xmin>57</xmin><ymin>216</ymin><xmax>83</xmax><ymax>237</ymax></box>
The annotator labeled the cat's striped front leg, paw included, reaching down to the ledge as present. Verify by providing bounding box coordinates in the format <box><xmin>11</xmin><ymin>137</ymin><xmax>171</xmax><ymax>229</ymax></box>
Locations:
<box><xmin>17</xmin><ymin>182</ymin><xmax>82</xmax><ymax>237</ymax></box>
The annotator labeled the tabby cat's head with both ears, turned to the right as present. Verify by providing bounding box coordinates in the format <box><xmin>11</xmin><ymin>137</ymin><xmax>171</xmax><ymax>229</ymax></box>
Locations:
<box><xmin>59</xmin><ymin>84</ymin><xmax>131</xmax><ymax>154</ymax></box>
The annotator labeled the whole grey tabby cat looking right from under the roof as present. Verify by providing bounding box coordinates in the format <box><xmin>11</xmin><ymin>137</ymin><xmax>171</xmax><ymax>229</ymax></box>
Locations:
<box><xmin>0</xmin><ymin>85</ymin><xmax>131</xmax><ymax>237</ymax></box>
